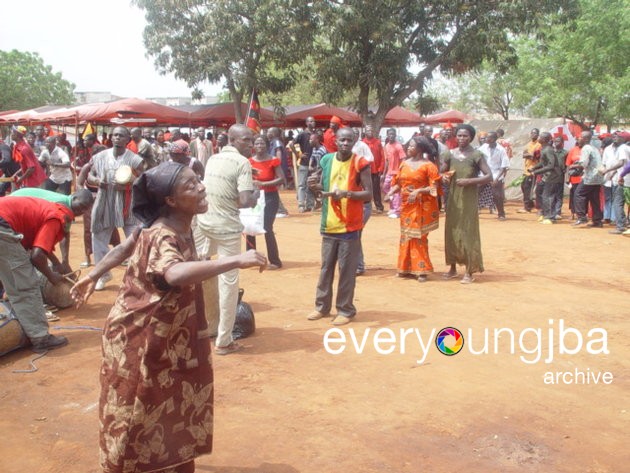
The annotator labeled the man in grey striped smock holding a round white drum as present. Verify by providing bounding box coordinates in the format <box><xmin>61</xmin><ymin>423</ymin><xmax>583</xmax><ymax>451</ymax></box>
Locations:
<box><xmin>87</xmin><ymin>126</ymin><xmax>144</xmax><ymax>291</ymax></box>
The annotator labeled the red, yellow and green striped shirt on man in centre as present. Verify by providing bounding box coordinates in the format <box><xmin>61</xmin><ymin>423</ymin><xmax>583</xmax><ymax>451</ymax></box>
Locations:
<box><xmin>319</xmin><ymin>153</ymin><xmax>370</xmax><ymax>234</ymax></box>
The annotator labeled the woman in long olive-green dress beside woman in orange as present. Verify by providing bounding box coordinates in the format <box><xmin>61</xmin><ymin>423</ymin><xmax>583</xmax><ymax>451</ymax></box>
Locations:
<box><xmin>441</xmin><ymin>125</ymin><xmax>492</xmax><ymax>284</ymax></box>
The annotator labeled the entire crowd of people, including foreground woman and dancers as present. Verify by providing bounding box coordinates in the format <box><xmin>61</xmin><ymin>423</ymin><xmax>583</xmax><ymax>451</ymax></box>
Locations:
<box><xmin>0</xmin><ymin>117</ymin><xmax>630</xmax><ymax>472</ymax></box>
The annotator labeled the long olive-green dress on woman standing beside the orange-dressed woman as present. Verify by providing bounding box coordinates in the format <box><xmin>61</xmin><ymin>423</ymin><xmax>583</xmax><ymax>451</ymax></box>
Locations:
<box><xmin>444</xmin><ymin>146</ymin><xmax>483</xmax><ymax>274</ymax></box>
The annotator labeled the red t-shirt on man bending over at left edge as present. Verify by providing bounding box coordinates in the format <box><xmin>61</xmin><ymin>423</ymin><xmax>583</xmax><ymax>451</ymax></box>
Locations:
<box><xmin>0</xmin><ymin>196</ymin><xmax>74</xmax><ymax>253</ymax></box>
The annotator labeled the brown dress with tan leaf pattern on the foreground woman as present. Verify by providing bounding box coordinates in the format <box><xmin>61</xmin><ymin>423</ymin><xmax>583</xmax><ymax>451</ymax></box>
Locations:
<box><xmin>99</xmin><ymin>224</ymin><xmax>214</xmax><ymax>473</ymax></box>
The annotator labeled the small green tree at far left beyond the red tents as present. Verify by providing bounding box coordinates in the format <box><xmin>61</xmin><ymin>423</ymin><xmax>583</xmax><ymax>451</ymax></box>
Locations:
<box><xmin>0</xmin><ymin>49</ymin><xmax>74</xmax><ymax>110</ymax></box>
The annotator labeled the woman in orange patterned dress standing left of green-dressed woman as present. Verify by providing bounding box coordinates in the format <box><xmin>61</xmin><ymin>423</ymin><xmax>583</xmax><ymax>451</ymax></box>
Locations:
<box><xmin>389</xmin><ymin>136</ymin><xmax>440</xmax><ymax>282</ymax></box>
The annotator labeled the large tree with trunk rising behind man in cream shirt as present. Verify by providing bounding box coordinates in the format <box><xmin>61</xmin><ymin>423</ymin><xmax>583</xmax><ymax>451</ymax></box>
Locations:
<box><xmin>133</xmin><ymin>0</ymin><xmax>314</xmax><ymax>121</ymax></box>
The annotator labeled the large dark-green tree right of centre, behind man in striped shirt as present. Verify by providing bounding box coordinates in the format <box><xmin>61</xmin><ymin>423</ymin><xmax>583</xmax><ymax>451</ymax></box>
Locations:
<box><xmin>317</xmin><ymin>0</ymin><xmax>575</xmax><ymax>126</ymax></box>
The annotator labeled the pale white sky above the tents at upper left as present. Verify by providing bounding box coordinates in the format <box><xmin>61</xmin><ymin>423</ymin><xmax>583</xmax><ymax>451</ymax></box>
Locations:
<box><xmin>0</xmin><ymin>0</ymin><xmax>221</xmax><ymax>98</ymax></box>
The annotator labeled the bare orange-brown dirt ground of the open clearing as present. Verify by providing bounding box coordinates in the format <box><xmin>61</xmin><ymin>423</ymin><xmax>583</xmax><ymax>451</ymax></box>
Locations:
<box><xmin>0</xmin><ymin>192</ymin><xmax>630</xmax><ymax>473</ymax></box>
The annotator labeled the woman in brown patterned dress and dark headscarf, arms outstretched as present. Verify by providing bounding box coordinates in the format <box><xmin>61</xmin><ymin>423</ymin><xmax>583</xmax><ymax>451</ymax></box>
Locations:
<box><xmin>99</xmin><ymin>162</ymin><xmax>267</xmax><ymax>473</ymax></box>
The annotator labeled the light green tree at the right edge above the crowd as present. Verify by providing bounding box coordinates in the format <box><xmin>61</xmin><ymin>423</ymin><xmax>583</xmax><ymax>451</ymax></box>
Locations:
<box><xmin>517</xmin><ymin>0</ymin><xmax>630</xmax><ymax>128</ymax></box>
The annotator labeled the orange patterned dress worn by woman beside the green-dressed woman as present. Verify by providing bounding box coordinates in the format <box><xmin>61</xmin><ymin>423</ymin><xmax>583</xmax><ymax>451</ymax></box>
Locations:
<box><xmin>393</xmin><ymin>161</ymin><xmax>440</xmax><ymax>276</ymax></box>
